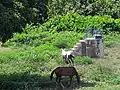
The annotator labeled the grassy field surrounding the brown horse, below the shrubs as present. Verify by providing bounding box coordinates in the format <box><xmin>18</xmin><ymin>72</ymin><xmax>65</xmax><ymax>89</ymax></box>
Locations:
<box><xmin>0</xmin><ymin>32</ymin><xmax>120</xmax><ymax>90</ymax></box>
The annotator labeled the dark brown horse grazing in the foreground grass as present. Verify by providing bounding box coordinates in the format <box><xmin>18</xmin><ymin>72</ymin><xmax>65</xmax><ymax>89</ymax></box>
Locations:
<box><xmin>50</xmin><ymin>67</ymin><xmax>80</xmax><ymax>84</ymax></box>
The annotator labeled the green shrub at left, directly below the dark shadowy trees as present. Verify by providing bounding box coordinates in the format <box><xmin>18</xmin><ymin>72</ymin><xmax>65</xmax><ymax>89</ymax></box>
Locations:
<box><xmin>5</xmin><ymin>25</ymin><xmax>50</xmax><ymax>47</ymax></box>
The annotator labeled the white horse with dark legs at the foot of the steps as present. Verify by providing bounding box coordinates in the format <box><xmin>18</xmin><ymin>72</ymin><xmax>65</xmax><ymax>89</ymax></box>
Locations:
<box><xmin>61</xmin><ymin>49</ymin><xmax>74</xmax><ymax>64</ymax></box>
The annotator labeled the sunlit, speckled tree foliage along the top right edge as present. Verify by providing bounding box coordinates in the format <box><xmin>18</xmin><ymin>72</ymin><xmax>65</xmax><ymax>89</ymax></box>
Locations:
<box><xmin>47</xmin><ymin>0</ymin><xmax>120</xmax><ymax>18</ymax></box>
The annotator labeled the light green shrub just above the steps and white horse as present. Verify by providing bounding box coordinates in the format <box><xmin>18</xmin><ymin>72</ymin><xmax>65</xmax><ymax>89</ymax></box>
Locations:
<box><xmin>52</xmin><ymin>31</ymin><xmax>84</xmax><ymax>48</ymax></box>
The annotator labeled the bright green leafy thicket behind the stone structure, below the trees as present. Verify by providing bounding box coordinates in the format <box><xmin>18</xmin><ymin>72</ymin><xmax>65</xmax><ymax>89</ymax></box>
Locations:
<box><xmin>35</xmin><ymin>13</ymin><xmax>120</xmax><ymax>32</ymax></box>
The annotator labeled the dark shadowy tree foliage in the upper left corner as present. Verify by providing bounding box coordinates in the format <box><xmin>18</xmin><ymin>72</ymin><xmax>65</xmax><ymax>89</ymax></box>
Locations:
<box><xmin>0</xmin><ymin>0</ymin><xmax>47</xmax><ymax>42</ymax></box>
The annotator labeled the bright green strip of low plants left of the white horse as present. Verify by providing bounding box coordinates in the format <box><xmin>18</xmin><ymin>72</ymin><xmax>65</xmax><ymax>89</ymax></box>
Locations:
<box><xmin>0</xmin><ymin>45</ymin><xmax>60</xmax><ymax>63</ymax></box>
